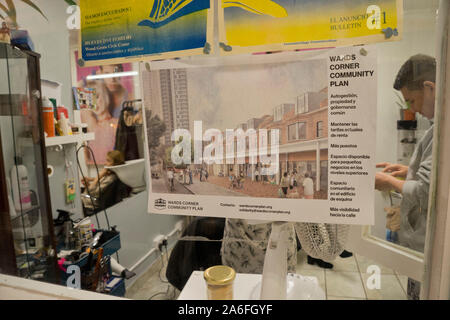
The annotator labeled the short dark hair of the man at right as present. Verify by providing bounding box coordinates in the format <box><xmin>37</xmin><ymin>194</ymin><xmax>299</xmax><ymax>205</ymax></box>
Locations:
<box><xmin>394</xmin><ymin>54</ymin><xmax>436</xmax><ymax>90</ymax></box>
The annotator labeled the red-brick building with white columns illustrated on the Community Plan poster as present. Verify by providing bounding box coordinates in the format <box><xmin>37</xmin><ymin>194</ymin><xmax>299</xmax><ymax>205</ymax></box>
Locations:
<box><xmin>207</xmin><ymin>88</ymin><xmax>328</xmax><ymax>191</ymax></box>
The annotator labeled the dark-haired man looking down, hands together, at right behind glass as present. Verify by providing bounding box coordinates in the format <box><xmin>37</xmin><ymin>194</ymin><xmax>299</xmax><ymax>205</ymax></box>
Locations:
<box><xmin>375</xmin><ymin>55</ymin><xmax>436</xmax><ymax>252</ymax></box>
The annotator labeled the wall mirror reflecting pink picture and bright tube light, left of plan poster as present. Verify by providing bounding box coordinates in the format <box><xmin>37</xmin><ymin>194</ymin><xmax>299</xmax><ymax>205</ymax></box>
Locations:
<box><xmin>73</xmin><ymin>52</ymin><xmax>146</xmax><ymax>215</ymax></box>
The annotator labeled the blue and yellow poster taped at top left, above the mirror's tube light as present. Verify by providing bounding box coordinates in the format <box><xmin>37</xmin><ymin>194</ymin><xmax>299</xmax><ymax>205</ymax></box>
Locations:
<box><xmin>80</xmin><ymin>0</ymin><xmax>213</xmax><ymax>65</ymax></box>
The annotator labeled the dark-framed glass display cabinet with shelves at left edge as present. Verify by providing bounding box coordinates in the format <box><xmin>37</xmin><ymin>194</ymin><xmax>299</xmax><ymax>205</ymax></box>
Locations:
<box><xmin>0</xmin><ymin>43</ymin><xmax>59</xmax><ymax>283</ymax></box>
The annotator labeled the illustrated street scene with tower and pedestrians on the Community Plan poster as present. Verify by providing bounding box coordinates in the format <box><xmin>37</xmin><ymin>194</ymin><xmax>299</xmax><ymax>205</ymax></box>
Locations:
<box><xmin>144</xmin><ymin>60</ymin><xmax>328</xmax><ymax>199</ymax></box>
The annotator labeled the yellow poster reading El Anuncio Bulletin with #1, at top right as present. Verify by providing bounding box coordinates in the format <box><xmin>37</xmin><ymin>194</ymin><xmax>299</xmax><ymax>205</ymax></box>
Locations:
<box><xmin>219</xmin><ymin>0</ymin><xmax>403</xmax><ymax>55</ymax></box>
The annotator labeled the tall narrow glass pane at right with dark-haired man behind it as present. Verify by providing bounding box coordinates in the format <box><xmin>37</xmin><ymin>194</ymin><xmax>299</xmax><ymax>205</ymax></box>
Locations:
<box><xmin>371</xmin><ymin>1</ymin><xmax>437</xmax><ymax>260</ymax></box>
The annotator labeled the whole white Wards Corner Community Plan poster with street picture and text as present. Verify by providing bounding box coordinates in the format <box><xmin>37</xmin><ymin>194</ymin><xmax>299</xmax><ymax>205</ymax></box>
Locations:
<box><xmin>143</xmin><ymin>47</ymin><xmax>377</xmax><ymax>224</ymax></box>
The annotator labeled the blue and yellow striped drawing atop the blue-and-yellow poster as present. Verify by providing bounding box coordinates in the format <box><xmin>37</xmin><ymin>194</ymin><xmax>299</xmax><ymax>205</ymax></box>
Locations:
<box><xmin>138</xmin><ymin>0</ymin><xmax>209</xmax><ymax>28</ymax></box>
